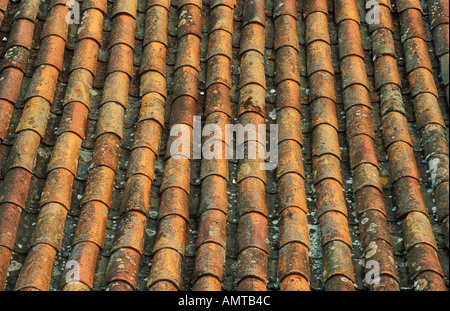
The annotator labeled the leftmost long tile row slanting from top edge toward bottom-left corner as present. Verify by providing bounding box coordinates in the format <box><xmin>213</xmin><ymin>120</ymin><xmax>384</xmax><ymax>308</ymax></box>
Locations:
<box><xmin>0</xmin><ymin>1</ymin><xmax>69</xmax><ymax>286</ymax></box>
